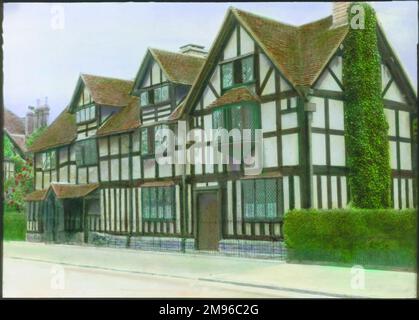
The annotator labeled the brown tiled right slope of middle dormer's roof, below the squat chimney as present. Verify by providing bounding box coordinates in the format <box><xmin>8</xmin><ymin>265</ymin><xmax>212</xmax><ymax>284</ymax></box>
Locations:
<box><xmin>149</xmin><ymin>48</ymin><xmax>205</xmax><ymax>85</ymax></box>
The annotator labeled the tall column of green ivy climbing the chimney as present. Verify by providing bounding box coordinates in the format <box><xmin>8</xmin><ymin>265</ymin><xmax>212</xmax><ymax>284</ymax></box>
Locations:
<box><xmin>343</xmin><ymin>3</ymin><xmax>391</xmax><ymax>209</ymax></box>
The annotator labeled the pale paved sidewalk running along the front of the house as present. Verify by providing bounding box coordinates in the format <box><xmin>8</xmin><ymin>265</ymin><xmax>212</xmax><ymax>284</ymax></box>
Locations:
<box><xmin>4</xmin><ymin>242</ymin><xmax>416</xmax><ymax>298</ymax></box>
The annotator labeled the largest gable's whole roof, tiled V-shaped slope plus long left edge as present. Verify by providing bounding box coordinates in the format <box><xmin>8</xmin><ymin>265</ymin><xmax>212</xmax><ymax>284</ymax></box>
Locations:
<box><xmin>176</xmin><ymin>8</ymin><xmax>348</xmax><ymax>120</ymax></box>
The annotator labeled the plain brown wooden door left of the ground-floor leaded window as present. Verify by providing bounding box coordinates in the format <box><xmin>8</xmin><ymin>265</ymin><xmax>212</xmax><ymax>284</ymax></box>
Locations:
<box><xmin>197</xmin><ymin>192</ymin><xmax>220</xmax><ymax>250</ymax></box>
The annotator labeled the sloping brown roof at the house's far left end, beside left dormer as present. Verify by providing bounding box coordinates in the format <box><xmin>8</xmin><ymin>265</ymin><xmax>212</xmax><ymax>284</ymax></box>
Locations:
<box><xmin>29</xmin><ymin>109</ymin><xmax>77</xmax><ymax>152</ymax></box>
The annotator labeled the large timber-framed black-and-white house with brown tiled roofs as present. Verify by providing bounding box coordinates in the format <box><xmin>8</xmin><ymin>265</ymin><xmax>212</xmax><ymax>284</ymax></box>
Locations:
<box><xmin>23</xmin><ymin>3</ymin><xmax>417</xmax><ymax>256</ymax></box>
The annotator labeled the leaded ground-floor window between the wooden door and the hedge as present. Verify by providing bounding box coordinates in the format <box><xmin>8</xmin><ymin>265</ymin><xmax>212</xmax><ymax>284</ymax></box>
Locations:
<box><xmin>242</xmin><ymin>179</ymin><xmax>278</xmax><ymax>220</ymax></box>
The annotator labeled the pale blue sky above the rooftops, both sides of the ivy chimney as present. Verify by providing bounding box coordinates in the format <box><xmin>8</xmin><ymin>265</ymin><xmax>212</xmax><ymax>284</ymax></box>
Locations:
<box><xmin>3</xmin><ymin>1</ymin><xmax>418</xmax><ymax>121</ymax></box>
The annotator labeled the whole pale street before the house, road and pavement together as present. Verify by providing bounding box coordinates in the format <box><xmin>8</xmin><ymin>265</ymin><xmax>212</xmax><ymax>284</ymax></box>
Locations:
<box><xmin>3</xmin><ymin>242</ymin><xmax>416</xmax><ymax>298</ymax></box>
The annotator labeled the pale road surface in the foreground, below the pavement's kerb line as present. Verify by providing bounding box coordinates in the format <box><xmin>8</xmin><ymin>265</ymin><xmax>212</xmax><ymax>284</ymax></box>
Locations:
<box><xmin>3</xmin><ymin>258</ymin><xmax>290</xmax><ymax>298</ymax></box>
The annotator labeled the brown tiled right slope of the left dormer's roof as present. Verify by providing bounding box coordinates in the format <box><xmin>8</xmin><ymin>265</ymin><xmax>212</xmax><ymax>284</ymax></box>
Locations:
<box><xmin>81</xmin><ymin>74</ymin><xmax>133</xmax><ymax>107</ymax></box>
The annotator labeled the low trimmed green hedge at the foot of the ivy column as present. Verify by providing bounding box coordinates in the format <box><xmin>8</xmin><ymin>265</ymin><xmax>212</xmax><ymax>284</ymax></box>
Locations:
<box><xmin>284</xmin><ymin>209</ymin><xmax>417</xmax><ymax>269</ymax></box>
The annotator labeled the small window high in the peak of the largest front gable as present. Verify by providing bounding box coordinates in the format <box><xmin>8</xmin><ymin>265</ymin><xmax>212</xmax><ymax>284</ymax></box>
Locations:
<box><xmin>221</xmin><ymin>55</ymin><xmax>255</xmax><ymax>90</ymax></box>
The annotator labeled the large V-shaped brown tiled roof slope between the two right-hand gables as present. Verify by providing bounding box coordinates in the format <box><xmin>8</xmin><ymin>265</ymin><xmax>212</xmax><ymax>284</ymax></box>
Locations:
<box><xmin>232</xmin><ymin>9</ymin><xmax>348</xmax><ymax>86</ymax></box>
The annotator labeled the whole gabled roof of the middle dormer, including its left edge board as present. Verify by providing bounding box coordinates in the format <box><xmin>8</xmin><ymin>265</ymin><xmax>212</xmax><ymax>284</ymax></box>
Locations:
<box><xmin>134</xmin><ymin>48</ymin><xmax>205</xmax><ymax>92</ymax></box>
